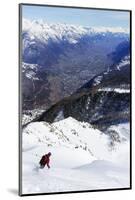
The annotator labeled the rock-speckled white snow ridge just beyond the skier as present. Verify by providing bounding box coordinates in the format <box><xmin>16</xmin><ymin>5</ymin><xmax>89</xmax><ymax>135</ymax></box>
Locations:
<box><xmin>23</xmin><ymin>117</ymin><xmax>108</xmax><ymax>159</ymax></box>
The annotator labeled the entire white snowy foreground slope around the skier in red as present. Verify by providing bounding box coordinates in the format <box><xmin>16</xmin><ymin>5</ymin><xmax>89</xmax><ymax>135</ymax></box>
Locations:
<box><xmin>22</xmin><ymin>117</ymin><xmax>130</xmax><ymax>194</ymax></box>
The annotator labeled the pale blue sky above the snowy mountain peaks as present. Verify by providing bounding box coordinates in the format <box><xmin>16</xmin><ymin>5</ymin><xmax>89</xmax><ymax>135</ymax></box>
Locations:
<box><xmin>22</xmin><ymin>5</ymin><xmax>130</xmax><ymax>28</ymax></box>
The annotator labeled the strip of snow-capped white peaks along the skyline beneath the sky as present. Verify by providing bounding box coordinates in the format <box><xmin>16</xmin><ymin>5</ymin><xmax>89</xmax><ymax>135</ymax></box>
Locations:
<box><xmin>22</xmin><ymin>19</ymin><xmax>128</xmax><ymax>43</ymax></box>
